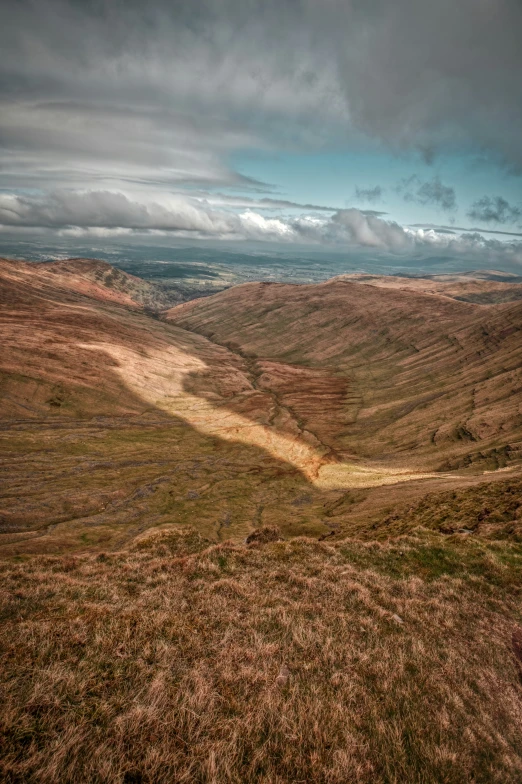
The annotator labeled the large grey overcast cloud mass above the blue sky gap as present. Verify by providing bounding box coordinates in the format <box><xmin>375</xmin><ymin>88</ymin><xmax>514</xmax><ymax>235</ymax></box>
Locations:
<box><xmin>0</xmin><ymin>0</ymin><xmax>522</xmax><ymax>193</ymax></box>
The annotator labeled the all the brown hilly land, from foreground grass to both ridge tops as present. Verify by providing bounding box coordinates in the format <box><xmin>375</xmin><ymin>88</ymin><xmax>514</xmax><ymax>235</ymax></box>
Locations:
<box><xmin>0</xmin><ymin>260</ymin><xmax>522</xmax><ymax>784</ymax></box>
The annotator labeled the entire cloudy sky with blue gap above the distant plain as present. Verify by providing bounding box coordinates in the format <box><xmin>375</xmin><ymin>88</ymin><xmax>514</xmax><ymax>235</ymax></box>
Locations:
<box><xmin>0</xmin><ymin>0</ymin><xmax>522</xmax><ymax>274</ymax></box>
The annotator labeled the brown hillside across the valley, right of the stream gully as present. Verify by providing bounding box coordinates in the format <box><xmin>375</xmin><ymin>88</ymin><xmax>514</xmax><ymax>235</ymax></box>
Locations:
<box><xmin>167</xmin><ymin>280</ymin><xmax>522</xmax><ymax>469</ymax></box>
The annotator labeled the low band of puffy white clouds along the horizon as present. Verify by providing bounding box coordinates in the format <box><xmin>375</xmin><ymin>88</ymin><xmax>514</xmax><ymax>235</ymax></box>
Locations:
<box><xmin>0</xmin><ymin>190</ymin><xmax>522</xmax><ymax>267</ymax></box>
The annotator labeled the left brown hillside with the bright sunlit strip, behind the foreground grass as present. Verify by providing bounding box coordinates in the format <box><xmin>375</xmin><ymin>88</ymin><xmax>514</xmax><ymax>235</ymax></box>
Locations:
<box><xmin>0</xmin><ymin>263</ymin><xmax>438</xmax><ymax>553</ymax></box>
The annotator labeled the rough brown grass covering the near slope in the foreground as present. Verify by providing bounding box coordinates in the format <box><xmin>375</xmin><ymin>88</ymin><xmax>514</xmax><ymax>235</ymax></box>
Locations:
<box><xmin>0</xmin><ymin>531</ymin><xmax>522</xmax><ymax>784</ymax></box>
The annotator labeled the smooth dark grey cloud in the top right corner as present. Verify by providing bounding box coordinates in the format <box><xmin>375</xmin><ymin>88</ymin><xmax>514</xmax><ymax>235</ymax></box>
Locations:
<box><xmin>332</xmin><ymin>0</ymin><xmax>522</xmax><ymax>171</ymax></box>
